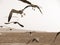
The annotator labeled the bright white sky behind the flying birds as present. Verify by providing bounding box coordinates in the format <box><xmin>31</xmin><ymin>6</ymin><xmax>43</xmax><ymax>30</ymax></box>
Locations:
<box><xmin>0</xmin><ymin>0</ymin><xmax>60</xmax><ymax>32</ymax></box>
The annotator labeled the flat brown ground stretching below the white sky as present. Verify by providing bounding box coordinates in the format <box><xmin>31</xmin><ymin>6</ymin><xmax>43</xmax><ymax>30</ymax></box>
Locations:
<box><xmin>0</xmin><ymin>28</ymin><xmax>60</xmax><ymax>45</ymax></box>
